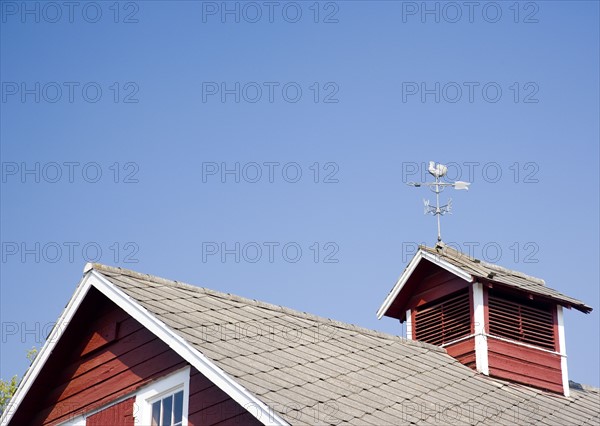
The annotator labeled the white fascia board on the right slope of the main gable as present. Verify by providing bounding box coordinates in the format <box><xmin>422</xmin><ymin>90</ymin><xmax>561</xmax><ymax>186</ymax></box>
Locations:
<box><xmin>89</xmin><ymin>270</ymin><xmax>289</xmax><ymax>425</ymax></box>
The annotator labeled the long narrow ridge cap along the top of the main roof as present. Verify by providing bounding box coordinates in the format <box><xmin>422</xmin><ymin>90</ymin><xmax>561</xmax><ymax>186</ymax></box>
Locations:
<box><xmin>84</xmin><ymin>263</ymin><xmax>447</xmax><ymax>353</ymax></box>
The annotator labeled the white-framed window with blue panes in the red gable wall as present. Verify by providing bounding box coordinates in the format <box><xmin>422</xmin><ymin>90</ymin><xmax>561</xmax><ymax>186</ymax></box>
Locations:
<box><xmin>135</xmin><ymin>367</ymin><xmax>190</xmax><ymax>426</ymax></box>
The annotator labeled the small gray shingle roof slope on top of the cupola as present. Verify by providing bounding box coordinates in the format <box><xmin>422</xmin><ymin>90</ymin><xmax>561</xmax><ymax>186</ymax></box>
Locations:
<box><xmin>419</xmin><ymin>243</ymin><xmax>592</xmax><ymax>314</ymax></box>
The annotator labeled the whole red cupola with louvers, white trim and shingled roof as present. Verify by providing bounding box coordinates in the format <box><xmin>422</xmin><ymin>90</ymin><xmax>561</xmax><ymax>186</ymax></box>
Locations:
<box><xmin>377</xmin><ymin>243</ymin><xmax>592</xmax><ymax>396</ymax></box>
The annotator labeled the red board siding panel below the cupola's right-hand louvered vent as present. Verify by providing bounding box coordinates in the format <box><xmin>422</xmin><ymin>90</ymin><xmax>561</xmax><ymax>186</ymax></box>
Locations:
<box><xmin>488</xmin><ymin>338</ymin><xmax>563</xmax><ymax>393</ymax></box>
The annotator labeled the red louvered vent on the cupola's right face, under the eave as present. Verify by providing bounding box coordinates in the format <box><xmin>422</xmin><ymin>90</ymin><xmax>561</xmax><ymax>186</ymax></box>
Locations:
<box><xmin>488</xmin><ymin>292</ymin><xmax>555</xmax><ymax>350</ymax></box>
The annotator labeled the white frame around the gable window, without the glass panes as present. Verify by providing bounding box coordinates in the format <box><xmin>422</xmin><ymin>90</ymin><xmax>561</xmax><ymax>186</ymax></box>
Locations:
<box><xmin>133</xmin><ymin>366</ymin><xmax>190</xmax><ymax>426</ymax></box>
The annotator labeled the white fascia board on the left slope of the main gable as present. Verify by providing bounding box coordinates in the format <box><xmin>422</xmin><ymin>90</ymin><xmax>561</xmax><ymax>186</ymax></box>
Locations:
<box><xmin>0</xmin><ymin>275</ymin><xmax>91</xmax><ymax>426</ymax></box>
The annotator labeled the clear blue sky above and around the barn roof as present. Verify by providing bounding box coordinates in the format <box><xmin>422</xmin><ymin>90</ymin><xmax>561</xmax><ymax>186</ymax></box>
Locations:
<box><xmin>0</xmin><ymin>1</ymin><xmax>600</xmax><ymax>386</ymax></box>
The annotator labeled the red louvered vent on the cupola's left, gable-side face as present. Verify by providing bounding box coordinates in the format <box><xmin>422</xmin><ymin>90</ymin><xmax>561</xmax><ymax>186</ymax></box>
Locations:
<box><xmin>415</xmin><ymin>290</ymin><xmax>471</xmax><ymax>346</ymax></box>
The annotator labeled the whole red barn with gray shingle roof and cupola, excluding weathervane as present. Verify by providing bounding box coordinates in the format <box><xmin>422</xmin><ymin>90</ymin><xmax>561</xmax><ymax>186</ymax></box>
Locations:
<box><xmin>0</xmin><ymin>247</ymin><xmax>600</xmax><ymax>426</ymax></box>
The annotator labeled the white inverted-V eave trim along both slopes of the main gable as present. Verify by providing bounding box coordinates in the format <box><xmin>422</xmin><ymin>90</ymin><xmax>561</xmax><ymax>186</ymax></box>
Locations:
<box><xmin>0</xmin><ymin>265</ymin><xmax>289</xmax><ymax>426</ymax></box>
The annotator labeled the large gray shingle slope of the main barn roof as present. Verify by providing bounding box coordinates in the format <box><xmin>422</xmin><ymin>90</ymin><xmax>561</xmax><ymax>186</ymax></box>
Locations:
<box><xmin>94</xmin><ymin>264</ymin><xmax>600</xmax><ymax>425</ymax></box>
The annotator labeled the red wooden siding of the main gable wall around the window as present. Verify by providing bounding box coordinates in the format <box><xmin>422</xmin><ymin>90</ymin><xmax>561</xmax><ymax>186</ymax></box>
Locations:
<box><xmin>10</xmin><ymin>288</ymin><xmax>257</xmax><ymax>426</ymax></box>
